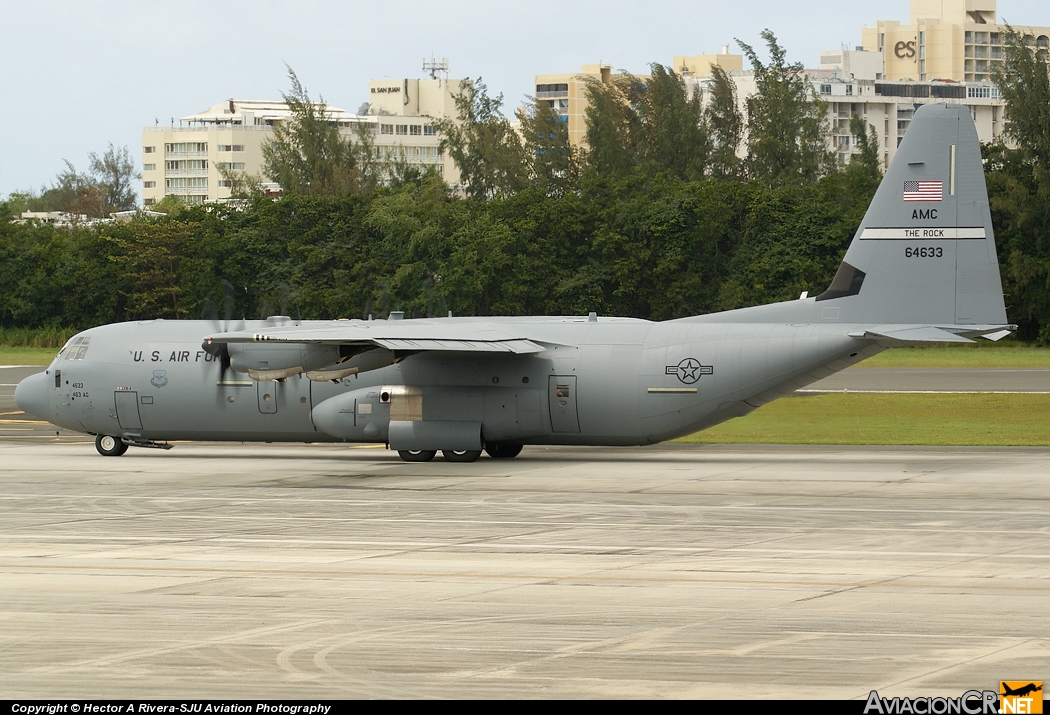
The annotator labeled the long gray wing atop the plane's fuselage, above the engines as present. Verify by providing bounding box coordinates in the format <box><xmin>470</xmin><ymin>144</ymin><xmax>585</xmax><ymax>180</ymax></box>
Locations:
<box><xmin>205</xmin><ymin>320</ymin><xmax>547</xmax><ymax>355</ymax></box>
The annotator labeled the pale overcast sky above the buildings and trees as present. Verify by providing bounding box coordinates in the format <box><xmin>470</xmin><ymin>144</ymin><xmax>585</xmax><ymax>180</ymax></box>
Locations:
<box><xmin>0</xmin><ymin>0</ymin><xmax>1050</xmax><ymax>195</ymax></box>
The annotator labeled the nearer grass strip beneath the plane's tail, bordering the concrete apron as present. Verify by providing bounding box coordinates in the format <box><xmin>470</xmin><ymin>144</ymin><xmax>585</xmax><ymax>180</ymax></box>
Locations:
<box><xmin>678</xmin><ymin>393</ymin><xmax>1050</xmax><ymax>446</ymax></box>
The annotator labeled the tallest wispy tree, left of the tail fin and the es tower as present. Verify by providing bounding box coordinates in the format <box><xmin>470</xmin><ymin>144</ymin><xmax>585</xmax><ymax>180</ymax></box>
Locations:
<box><xmin>737</xmin><ymin>29</ymin><xmax>835</xmax><ymax>187</ymax></box>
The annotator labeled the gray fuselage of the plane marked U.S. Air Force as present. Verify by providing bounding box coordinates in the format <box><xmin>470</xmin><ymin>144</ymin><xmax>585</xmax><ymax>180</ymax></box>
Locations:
<box><xmin>25</xmin><ymin>312</ymin><xmax>881</xmax><ymax>445</ymax></box>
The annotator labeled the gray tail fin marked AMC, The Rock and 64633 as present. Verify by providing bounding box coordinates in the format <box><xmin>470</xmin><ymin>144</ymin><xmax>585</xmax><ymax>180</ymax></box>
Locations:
<box><xmin>816</xmin><ymin>104</ymin><xmax>1006</xmax><ymax>325</ymax></box>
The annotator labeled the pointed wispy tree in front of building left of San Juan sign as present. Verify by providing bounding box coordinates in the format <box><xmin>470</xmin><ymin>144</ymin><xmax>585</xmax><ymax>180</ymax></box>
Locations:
<box><xmin>263</xmin><ymin>67</ymin><xmax>366</xmax><ymax>196</ymax></box>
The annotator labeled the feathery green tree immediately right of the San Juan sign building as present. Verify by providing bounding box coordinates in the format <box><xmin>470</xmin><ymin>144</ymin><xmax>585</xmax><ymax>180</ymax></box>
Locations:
<box><xmin>434</xmin><ymin>77</ymin><xmax>528</xmax><ymax>198</ymax></box>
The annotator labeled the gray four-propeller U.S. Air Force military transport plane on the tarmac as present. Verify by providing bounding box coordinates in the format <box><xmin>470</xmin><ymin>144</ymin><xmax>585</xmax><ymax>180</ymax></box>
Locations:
<box><xmin>15</xmin><ymin>104</ymin><xmax>1015</xmax><ymax>462</ymax></box>
